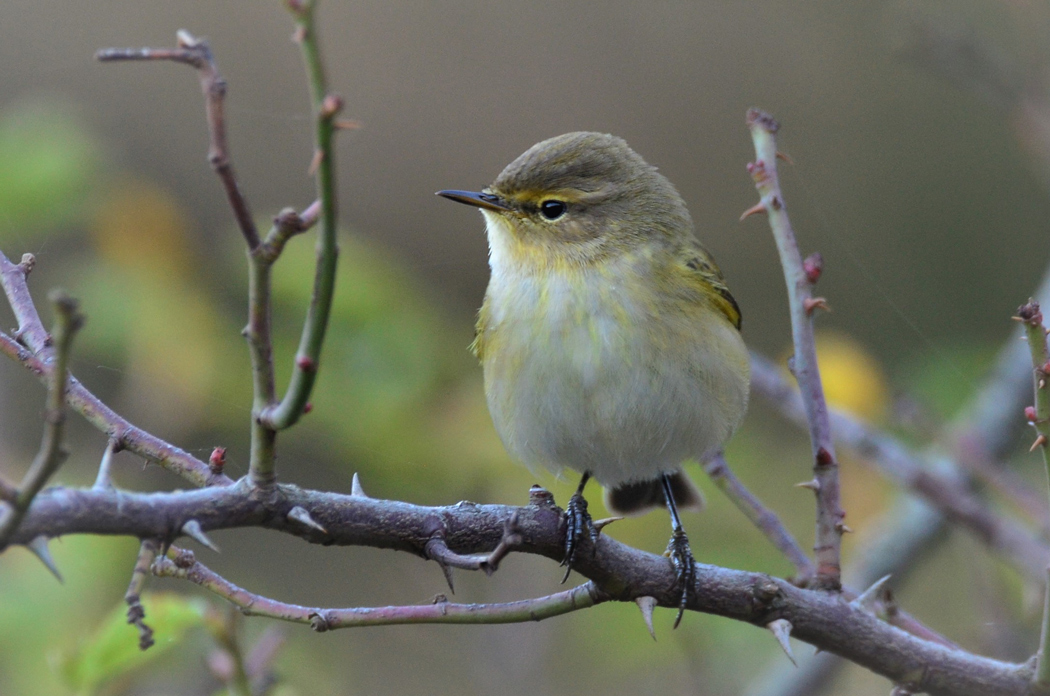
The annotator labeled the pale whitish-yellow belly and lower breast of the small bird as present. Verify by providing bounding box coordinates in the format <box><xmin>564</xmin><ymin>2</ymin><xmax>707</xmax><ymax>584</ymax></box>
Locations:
<box><xmin>484</xmin><ymin>258</ymin><xmax>748</xmax><ymax>486</ymax></box>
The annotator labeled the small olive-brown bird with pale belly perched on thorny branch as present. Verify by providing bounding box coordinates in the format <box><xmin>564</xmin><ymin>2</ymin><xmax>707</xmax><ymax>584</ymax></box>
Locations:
<box><xmin>438</xmin><ymin>132</ymin><xmax>750</xmax><ymax>627</ymax></box>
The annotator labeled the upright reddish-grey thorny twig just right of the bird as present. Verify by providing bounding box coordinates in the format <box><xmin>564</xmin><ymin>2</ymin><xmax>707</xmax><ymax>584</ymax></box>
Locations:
<box><xmin>748</xmin><ymin>109</ymin><xmax>845</xmax><ymax>590</ymax></box>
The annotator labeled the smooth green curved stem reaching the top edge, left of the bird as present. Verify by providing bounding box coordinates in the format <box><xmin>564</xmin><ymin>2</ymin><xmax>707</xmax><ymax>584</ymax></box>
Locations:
<box><xmin>260</xmin><ymin>2</ymin><xmax>342</xmax><ymax>430</ymax></box>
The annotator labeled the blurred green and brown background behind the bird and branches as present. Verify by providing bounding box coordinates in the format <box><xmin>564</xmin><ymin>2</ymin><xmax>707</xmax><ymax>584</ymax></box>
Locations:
<box><xmin>0</xmin><ymin>0</ymin><xmax>1050</xmax><ymax>696</ymax></box>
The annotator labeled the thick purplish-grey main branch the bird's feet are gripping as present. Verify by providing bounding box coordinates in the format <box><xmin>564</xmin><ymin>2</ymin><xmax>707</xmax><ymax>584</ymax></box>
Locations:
<box><xmin>6</xmin><ymin>481</ymin><xmax>1032</xmax><ymax>696</ymax></box>
